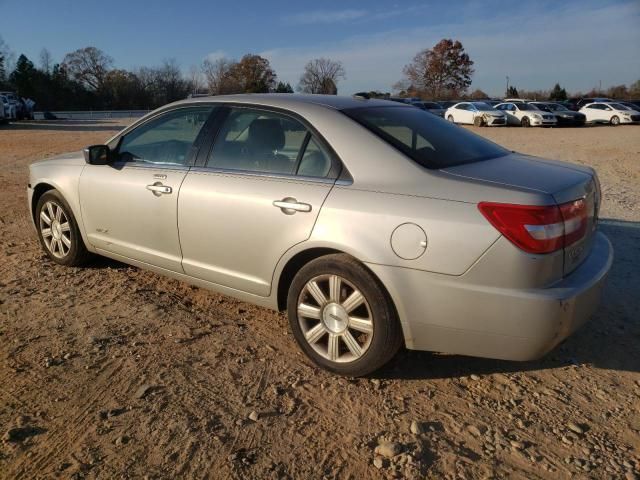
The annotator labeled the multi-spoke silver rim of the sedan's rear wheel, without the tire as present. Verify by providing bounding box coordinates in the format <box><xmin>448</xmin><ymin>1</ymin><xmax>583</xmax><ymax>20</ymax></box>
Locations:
<box><xmin>298</xmin><ymin>275</ymin><xmax>374</xmax><ymax>363</ymax></box>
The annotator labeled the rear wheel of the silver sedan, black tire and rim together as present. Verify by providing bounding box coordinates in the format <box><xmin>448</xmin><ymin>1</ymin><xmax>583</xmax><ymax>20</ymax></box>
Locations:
<box><xmin>287</xmin><ymin>254</ymin><xmax>403</xmax><ymax>377</ymax></box>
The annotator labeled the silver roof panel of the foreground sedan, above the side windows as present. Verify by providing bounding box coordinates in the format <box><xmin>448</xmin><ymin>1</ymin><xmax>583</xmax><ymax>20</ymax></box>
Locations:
<box><xmin>171</xmin><ymin>93</ymin><xmax>400</xmax><ymax>110</ymax></box>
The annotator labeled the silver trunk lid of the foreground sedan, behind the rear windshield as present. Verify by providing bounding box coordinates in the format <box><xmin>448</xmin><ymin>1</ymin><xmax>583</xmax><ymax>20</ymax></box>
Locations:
<box><xmin>442</xmin><ymin>153</ymin><xmax>600</xmax><ymax>275</ymax></box>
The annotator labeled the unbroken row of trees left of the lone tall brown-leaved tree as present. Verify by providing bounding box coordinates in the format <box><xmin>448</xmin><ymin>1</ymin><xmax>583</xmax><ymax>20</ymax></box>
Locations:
<box><xmin>0</xmin><ymin>38</ymin><xmax>346</xmax><ymax>111</ymax></box>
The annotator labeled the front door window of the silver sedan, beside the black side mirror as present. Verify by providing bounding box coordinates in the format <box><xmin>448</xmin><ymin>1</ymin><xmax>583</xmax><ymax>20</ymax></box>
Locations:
<box><xmin>118</xmin><ymin>106</ymin><xmax>213</xmax><ymax>165</ymax></box>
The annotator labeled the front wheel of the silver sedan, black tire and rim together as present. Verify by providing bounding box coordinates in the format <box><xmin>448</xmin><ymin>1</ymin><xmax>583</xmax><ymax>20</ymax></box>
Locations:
<box><xmin>35</xmin><ymin>190</ymin><xmax>91</xmax><ymax>267</ymax></box>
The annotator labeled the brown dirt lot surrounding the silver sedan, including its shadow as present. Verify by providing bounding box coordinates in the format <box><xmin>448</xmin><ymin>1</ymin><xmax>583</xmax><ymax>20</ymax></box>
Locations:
<box><xmin>0</xmin><ymin>121</ymin><xmax>640</xmax><ymax>480</ymax></box>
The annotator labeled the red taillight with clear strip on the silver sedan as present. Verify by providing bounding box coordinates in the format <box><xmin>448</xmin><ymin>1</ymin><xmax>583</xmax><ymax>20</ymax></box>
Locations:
<box><xmin>478</xmin><ymin>199</ymin><xmax>587</xmax><ymax>253</ymax></box>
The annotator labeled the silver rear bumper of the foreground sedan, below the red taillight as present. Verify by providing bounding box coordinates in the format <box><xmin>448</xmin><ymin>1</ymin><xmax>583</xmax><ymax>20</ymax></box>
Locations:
<box><xmin>369</xmin><ymin>233</ymin><xmax>613</xmax><ymax>360</ymax></box>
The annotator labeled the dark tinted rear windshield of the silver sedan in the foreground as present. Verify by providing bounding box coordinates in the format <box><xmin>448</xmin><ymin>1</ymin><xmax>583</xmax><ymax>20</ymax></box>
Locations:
<box><xmin>343</xmin><ymin>106</ymin><xmax>509</xmax><ymax>169</ymax></box>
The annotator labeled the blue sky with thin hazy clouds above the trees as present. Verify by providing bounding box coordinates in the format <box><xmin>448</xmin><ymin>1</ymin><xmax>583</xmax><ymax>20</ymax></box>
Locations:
<box><xmin>0</xmin><ymin>0</ymin><xmax>640</xmax><ymax>95</ymax></box>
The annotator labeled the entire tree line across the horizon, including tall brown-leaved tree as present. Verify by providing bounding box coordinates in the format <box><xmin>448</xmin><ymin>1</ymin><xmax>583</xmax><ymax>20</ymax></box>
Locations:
<box><xmin>0</xmin><ymin>37</ymin><xmax>640</xmax><ymax>110</ymax></box>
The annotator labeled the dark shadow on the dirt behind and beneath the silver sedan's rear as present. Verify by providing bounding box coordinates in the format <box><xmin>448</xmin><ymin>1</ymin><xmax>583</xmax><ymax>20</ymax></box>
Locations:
<box><xmin>371</xmin><ymin>219</ymin><xmax>640</xmax><ymax>379</ymax></box>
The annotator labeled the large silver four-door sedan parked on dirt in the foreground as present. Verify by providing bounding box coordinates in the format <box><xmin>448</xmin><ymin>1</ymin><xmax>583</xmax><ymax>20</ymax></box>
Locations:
<box><xmin>28</xmin><ymin>95</ymin><xmax>613</xmax><ymax>375</ymax></box>
